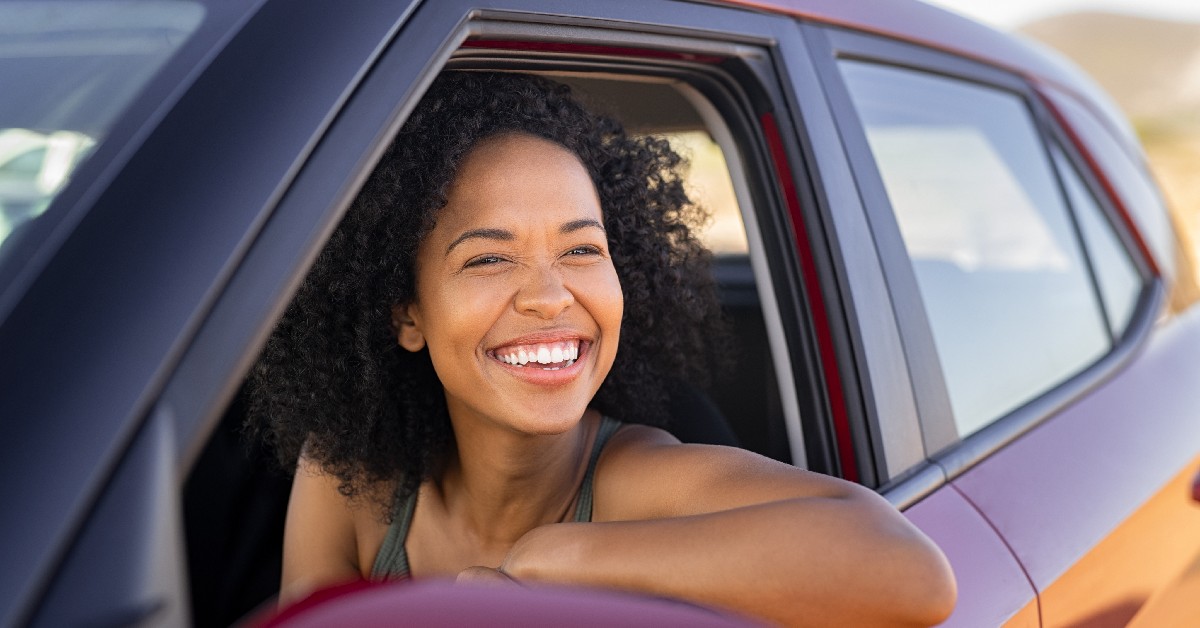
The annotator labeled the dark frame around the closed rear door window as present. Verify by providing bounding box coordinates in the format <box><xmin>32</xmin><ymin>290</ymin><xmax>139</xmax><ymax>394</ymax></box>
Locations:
<box><xmin>815</xmin><ymin>26</ymin><xmax>1162</xmax><ymax>492</ymax></box>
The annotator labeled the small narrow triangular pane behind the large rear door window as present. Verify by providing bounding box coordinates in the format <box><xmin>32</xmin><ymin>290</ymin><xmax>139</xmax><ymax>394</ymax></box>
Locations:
<box><xmin>1054</xmin><ymin>146</ymin><xmax>1141</xmax><ymax>336</ymax></box>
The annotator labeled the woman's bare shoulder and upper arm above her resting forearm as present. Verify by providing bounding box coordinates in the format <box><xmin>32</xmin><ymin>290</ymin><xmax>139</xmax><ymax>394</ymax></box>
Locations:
<box><xmin>594</xmin><ymin>425</ymin><xmax>866</xmax><ymax>521</ymax></box>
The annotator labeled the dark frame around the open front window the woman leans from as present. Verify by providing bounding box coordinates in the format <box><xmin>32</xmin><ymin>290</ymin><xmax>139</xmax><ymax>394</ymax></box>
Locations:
<box><xmin>158</xmin><ymin>0</ymin><xmax>873</xmax><ymax>487</ymax></box>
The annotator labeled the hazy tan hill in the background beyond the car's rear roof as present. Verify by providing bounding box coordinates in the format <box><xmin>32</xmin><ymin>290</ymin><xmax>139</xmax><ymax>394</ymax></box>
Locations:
<box><xmin>1018</xmin><ymin>12</ymin><xmax>1200</xmax><ymax>126</ymax></box>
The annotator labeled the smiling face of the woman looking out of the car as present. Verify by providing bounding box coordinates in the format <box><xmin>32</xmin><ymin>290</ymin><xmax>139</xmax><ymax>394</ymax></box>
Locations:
<box><xmin>394</xmin><ymin>133</ymin><xmax>624</xmax><ymax>433</ymax></box>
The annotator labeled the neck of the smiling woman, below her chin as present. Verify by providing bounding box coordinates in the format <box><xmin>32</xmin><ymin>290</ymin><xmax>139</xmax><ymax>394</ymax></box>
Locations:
<box><xmin>439</xmin><ymin>411</ymin><xmax>599</xmax><ymax>546</ymax></box>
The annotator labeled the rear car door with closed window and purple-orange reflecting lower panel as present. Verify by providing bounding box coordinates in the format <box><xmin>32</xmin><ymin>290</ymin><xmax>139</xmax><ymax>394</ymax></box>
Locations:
<box><xmin>823</xmin><ymin>17</ymin><xmax>1200</xmax><ymax>626</ymax></box>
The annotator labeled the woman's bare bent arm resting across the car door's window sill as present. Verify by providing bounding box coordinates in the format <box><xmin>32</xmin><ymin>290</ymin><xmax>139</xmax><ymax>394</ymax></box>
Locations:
<box><xmin>502</xmin><ymin>426</ymin><xmax>955</xmax><ymax>626</ymax></box>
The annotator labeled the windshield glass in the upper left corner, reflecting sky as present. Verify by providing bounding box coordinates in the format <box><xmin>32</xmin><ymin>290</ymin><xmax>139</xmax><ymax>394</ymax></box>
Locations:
<box><xmin>0</xmin><ymin>0</ymin><xmax>204</xmax><ymax>274</ymax></box>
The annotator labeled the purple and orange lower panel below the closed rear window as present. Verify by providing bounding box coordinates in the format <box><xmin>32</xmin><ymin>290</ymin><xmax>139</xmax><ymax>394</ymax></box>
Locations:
<box><xmin>953</xmin><ymin>304</ymin><xmax>1200</xmax><ymax>624</ymax></box>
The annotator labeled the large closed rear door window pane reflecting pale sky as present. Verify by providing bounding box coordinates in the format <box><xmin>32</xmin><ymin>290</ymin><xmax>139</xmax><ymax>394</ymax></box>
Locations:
<box><xmin>841</xmin><ymin>62</ymin><xmax>1110</xmax><ymax>436</ymax></box>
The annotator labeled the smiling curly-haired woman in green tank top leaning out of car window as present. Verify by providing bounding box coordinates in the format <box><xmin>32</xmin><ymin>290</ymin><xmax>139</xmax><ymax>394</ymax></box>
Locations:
<box><xmin>256</xmin><ymin>72</ymin><xmax>954</xmax><ymax>624</ymax></box>
